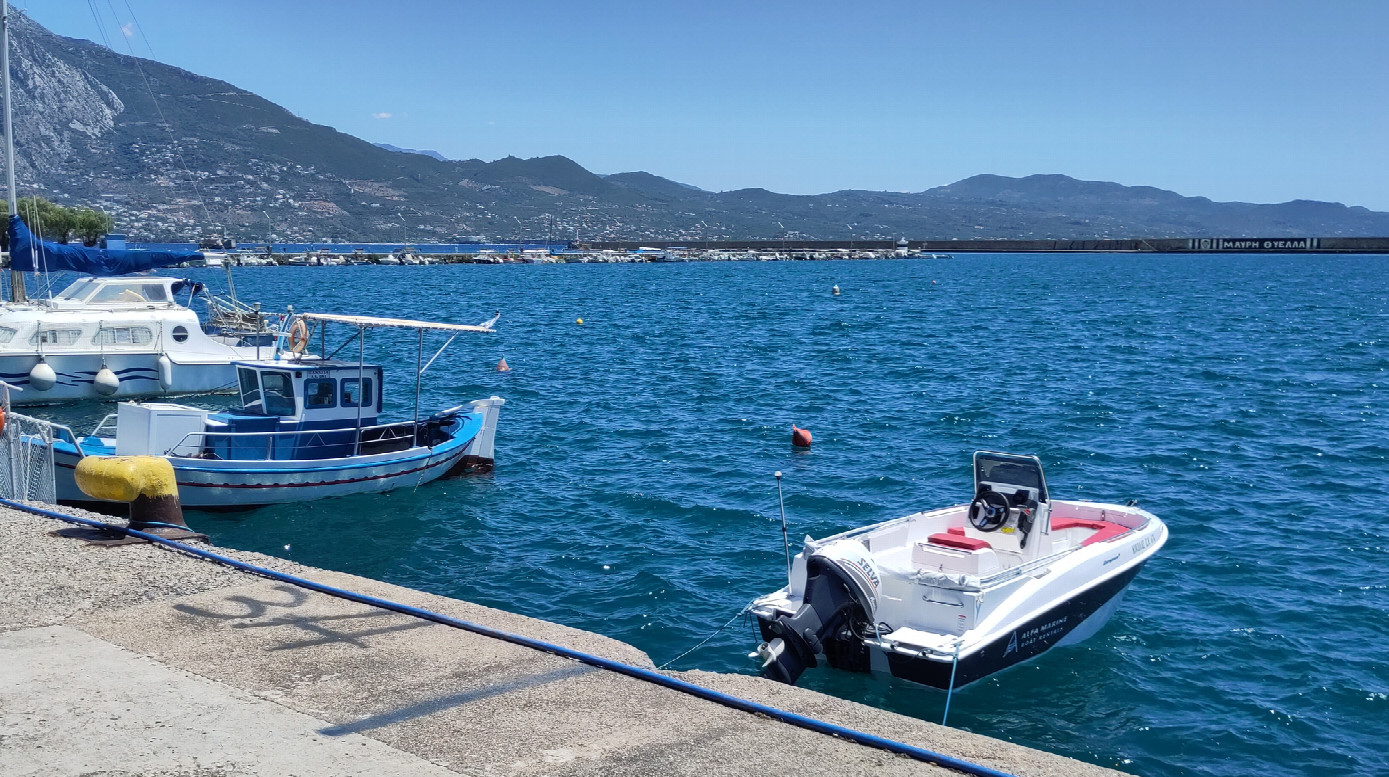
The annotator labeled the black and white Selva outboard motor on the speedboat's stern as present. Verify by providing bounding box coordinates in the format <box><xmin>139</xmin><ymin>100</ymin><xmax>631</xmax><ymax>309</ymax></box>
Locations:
<box><xmin>757</xmin><ymin>539</ymin><xmax>879</xmax><ymax>684</ymax></box>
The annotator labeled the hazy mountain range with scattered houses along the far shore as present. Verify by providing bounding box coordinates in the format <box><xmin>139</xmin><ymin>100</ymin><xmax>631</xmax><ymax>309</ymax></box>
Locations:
<box><xmin>11</xmin><ymin>10</ymin><xmax>1389</xmax><ymax>242</ymax></box>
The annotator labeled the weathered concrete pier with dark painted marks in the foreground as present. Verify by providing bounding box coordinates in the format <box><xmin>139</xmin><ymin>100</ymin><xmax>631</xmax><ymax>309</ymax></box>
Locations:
<box><xmin>0</xmin><ymin>507</ymin><xmax>1117</xmax><ymax>777</ymax></box>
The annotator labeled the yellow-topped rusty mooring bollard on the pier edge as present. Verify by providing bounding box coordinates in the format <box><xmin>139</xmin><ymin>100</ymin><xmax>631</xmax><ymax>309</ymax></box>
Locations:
<box><xmin>72</xmin><ymin>456</ymin><xmax>207</xmax><ymax>545</ymax></box>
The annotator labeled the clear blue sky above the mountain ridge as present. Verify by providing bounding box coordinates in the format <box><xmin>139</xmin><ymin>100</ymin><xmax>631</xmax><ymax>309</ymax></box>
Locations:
<box><xmin>13</xmin><ymin>0</ymin><xmax>1389</xmax><ymax>210</ymax></box>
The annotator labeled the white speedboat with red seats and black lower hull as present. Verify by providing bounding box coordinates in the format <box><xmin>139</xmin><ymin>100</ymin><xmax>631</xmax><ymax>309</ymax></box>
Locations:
<box><xmin>751</xmin><ymin>452</ymin><xmax>1167</xmax><ymax>688</ymax></box>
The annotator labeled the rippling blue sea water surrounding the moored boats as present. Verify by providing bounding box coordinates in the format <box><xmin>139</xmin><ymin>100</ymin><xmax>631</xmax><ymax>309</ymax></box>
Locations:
<box><xmin>32</xmin><ymin>254</ymin><xmax>1389</xmax><ymax>777</ymax></box>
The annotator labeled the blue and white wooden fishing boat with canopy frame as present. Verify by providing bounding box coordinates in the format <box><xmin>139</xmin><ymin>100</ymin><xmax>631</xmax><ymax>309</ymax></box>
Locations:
<box><xmin>53</xmin><ymin>314</ymin><xmax>504</xmax><ymax>510</ymax></box>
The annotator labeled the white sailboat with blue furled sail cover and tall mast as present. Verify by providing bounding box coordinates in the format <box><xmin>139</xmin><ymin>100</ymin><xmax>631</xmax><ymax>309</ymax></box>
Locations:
<box><xmin>0</xmin><ymin>0</ymin><xmax>284</xmax><ymax>404</ymax></box>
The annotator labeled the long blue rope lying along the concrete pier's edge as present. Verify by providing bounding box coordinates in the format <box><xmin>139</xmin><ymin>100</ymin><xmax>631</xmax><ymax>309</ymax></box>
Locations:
<box><xmin>0</xmin><ymin>498</ymin><xmax>1013</xmax><ymax>777</ymax></box>
